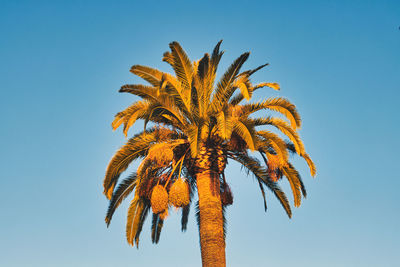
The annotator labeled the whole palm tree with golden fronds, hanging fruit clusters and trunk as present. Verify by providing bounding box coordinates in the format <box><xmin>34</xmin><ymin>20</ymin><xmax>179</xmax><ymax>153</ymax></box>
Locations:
<box><xmin>104</xmin><ymin>41</ymin><xmax>316</xmax><ymax>266</ymax></box>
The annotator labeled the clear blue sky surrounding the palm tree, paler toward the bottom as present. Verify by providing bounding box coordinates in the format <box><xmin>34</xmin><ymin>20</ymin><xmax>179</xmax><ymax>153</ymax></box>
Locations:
<box><xmin>0</xmin><ymin>0</ymin><xmax>400</xmax><ymax>267</ymax></box>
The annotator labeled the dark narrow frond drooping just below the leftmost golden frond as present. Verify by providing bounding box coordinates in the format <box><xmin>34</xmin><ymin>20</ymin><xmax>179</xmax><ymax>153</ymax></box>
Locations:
<box><xmin>105</xmin><ymin>173</ymin><xmax>137</xmax><ymax>227</ymax></box>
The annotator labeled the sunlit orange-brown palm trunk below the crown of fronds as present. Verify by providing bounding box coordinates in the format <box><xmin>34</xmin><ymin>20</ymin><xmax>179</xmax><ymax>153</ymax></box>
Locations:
<box><xmin>196</xmin><ymin>170</ymin><xmax>226</xmax><ymax>267</ymax></box>
